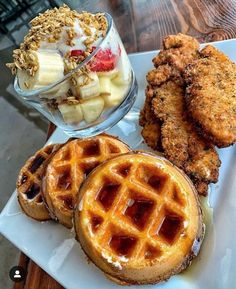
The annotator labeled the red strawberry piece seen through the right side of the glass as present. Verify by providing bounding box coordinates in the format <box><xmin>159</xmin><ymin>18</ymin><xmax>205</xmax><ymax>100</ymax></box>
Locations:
<box><xmin>90</xmin><ymin>48</ymin><xmax>118</xmax><ymax>71</ymax></box>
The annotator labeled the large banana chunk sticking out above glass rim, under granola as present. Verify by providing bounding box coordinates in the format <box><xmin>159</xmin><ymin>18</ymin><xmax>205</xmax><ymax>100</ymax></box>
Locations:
<box><xmin>17</xmin><ymin>50</ymin><xmax>64</xmax><ymax>90</ymax></box>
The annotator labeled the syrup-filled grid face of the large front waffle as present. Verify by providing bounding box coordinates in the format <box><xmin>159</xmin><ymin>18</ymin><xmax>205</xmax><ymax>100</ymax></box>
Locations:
<box><xmin>82</xmin><ymin>161</ymin><xmax>188</xmax><ymax>259</ymax></box>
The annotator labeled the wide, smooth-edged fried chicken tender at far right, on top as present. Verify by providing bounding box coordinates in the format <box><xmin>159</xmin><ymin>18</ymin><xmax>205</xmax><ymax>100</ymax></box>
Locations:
<box><xmin>184</xmin><ymin>45</ymin><xmax>236</xmax><ymax>147</ymax></box>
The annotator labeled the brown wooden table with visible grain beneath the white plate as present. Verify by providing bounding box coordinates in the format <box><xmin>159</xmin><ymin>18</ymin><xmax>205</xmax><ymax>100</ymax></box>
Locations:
<box><xmin>14</xmin><ymin>0</ymin><xmax>236</xmax><ymax>289</ymax></box>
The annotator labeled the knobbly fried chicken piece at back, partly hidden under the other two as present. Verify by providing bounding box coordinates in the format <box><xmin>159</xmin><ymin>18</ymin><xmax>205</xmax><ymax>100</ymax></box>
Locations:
<box><xmin>139</xmin><ymin>33</ymin><xmax>199</xmax><ymax>150</ymax></box>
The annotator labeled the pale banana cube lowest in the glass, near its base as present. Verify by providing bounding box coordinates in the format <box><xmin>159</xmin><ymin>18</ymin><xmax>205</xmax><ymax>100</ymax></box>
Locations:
<box><xmin>58</xmin><ymin>103</ymin><xmax>83</xmax><ymax>124</ymax></box>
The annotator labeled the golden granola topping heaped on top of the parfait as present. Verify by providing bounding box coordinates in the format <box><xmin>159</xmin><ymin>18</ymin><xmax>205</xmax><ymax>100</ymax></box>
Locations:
<box><xmin>7</xmin><ymin>5</ymin><xmax>108</xmax><ymax>76</ymax></box>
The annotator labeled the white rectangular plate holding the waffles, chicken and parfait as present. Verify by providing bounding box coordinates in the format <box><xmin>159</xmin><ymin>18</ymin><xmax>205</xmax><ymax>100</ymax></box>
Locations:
<box><xmin>0</xmin><ymin>39</ymin><xmax>236</xmax><ymax>289</ymax></box>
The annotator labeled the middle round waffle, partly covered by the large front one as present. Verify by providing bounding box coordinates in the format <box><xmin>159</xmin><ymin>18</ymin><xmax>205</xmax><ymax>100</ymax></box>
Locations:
<box><xmin>43</xmin><ymin>134</ymin><xmax>130</xmax><ymax>228</ymax></box>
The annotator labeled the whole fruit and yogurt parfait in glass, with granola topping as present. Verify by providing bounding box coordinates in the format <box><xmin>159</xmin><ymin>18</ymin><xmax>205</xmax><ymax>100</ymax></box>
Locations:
<box><xmin>7</xmin><ymin>5</ymin><xmax>135</xmax><ymax>135</ymax></box>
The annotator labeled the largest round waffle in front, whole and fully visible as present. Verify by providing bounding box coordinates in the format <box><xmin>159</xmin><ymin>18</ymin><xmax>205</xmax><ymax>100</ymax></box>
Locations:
<box><xmin>74</xmin><ymin>152</ymin><xmax>204</xmax><ymax>285</ymax></box>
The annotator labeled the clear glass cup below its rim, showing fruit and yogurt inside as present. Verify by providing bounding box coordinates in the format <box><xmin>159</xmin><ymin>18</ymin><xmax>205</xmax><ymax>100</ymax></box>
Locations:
<box><xmin>14</xmin><ymin>13</ymin><xmax>138</xmax><ymax>137</ymax></box>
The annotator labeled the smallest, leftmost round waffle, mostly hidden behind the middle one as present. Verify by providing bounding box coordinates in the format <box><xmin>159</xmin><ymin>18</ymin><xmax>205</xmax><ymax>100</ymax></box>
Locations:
<box><xmin>16</xmin><ymin>144</ymin><xmax>60</xmax><ymax>221</ymax></box>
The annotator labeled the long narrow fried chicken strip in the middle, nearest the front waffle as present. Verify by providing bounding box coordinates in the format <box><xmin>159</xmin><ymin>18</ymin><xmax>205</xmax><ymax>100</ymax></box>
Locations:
<box><xmin>152</xmin><ymin>80</ymin><xmax>220</xmax><ymax>183</ymax></box>
